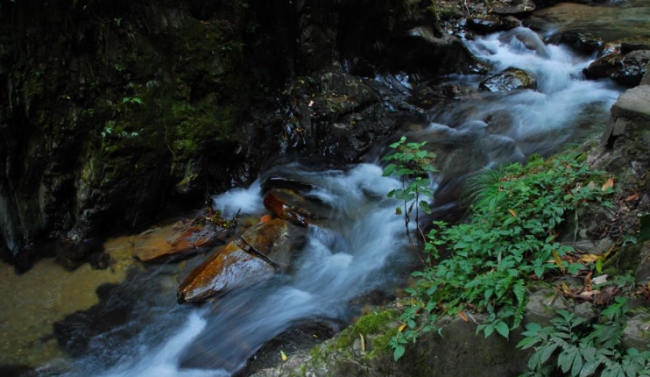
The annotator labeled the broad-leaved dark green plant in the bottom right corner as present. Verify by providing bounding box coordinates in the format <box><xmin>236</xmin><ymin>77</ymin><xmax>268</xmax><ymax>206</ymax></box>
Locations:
<box><xmin>517</xmin><ymin>297</ymin><xmax>650</xmax><ymax>377</ymax></box>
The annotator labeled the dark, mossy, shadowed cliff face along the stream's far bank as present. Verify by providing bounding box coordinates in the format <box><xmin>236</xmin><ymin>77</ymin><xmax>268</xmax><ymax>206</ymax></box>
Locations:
<box><xmin>0</xmin><ymin>0</ymin><xmax>475</xmax><ymax>265</ymax></box>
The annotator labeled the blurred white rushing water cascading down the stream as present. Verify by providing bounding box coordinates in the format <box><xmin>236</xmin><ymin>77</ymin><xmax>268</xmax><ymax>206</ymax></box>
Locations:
<box><xmin>17</xmin><ymin>23</ymin><xmax>619</xmax><ymax>377</ymax></box>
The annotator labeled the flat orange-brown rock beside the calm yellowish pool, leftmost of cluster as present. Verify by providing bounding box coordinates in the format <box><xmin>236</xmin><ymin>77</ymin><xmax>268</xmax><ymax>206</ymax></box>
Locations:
<box><xmin>133</xmin><ymin>209</ymin><xmax>237</xmax><ymax>262</ymax></box>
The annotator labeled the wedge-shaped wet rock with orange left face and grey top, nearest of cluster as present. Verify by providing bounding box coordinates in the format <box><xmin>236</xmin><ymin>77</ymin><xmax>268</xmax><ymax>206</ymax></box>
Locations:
<box><xmin>177</xmin><ymin>242</ymin><xmax>275</xmax><ymax>304</ymax></box>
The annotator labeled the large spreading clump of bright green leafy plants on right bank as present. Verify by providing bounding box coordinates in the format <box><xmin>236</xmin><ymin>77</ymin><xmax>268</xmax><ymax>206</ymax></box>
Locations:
<box><xmin>391</xmin><ymin>155</ymin><xmax>613</xmax><ymax>359</ymax></box>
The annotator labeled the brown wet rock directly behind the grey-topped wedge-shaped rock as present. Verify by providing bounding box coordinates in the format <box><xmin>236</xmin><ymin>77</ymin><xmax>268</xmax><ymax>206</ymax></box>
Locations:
<box><xmin>239</xmin><ymin>219</ymin><xmax>305</xmax><ymax>270</ymax></box>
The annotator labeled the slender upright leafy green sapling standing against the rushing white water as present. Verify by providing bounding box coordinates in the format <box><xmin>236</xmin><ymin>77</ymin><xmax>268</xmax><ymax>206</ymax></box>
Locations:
<box><xmin>384</xmin><ymin>137</ymin><xmax>436</xmax><ymax>247</ymax></box>
